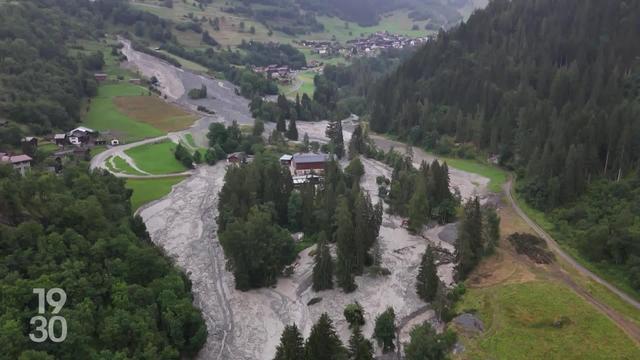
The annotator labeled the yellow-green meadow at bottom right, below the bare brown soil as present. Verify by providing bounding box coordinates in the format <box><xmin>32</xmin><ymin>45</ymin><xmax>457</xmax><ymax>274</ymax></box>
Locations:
<box><xmin>458</xmin><ymin>281</ymin><xmax>640</xmax><ymax>359</ymax></box>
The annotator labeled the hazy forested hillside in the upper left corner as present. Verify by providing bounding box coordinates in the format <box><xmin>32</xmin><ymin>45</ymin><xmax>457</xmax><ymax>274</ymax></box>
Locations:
<box><xmin>0</xmin><ymin>0</ymin><xmax>171</xmax><ymax>139</ymax></box>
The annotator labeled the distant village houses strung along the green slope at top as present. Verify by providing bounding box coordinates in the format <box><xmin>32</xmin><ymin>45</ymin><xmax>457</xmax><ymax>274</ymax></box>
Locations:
<box><xmin>300</xmin><ymin>31</ymin><xmax>431</xmax><ymax>58</ymax></box>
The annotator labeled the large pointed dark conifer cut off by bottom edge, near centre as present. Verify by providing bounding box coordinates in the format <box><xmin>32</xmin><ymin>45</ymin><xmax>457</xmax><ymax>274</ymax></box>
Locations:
<box><xmin>304</xmin><ymin>313</ymin><xmax>346</xmax><ymax>360</ymax></box>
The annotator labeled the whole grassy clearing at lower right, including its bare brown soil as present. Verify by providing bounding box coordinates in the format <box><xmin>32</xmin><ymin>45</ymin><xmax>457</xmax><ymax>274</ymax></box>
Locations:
<box><xmin>454</xmin><ymin>198</ymin><xmax>640</xmax><ymax>359</ymax></box>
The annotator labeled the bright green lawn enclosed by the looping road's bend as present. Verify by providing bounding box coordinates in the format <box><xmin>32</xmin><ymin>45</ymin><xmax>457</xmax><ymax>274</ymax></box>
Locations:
<box><xmin>125</xmin><ymin>140</ymin><xmax>187</xmax><ymax>174</ymax></box>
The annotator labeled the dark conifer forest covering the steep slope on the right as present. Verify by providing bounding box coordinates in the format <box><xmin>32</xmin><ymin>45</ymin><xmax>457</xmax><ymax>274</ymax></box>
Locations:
<box><xmin>369</xmin><ymin>0</ymin><xmax>640</xmax><ymax>287</ymax></box>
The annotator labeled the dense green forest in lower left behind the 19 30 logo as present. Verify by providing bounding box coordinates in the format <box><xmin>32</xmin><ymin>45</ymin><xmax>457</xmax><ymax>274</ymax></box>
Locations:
<box><xmin>0</xmin><ymin>166</ymin><xmax>207</xmax><ymax>360</ymax></box>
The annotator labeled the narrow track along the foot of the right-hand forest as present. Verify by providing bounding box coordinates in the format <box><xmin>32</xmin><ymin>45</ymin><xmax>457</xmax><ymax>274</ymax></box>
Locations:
<box><xmin>504</xmin><ymin>179</ymin><xmax>640</xmax><ymax>310</ymax></box>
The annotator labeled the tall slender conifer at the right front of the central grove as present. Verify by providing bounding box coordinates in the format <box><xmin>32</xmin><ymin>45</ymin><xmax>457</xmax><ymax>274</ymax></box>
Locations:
<box><xmin>336</xmin><ymin>196</ymin><xmax>356</xmax><ymax>292</ymax></box>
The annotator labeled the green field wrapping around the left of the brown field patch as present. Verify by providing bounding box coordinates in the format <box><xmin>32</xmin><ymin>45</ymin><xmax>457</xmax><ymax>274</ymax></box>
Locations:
<box><xmin>83</xmin><ymin>83</ymin><xmax>163</xmax><ymax>142</ymax></box>
